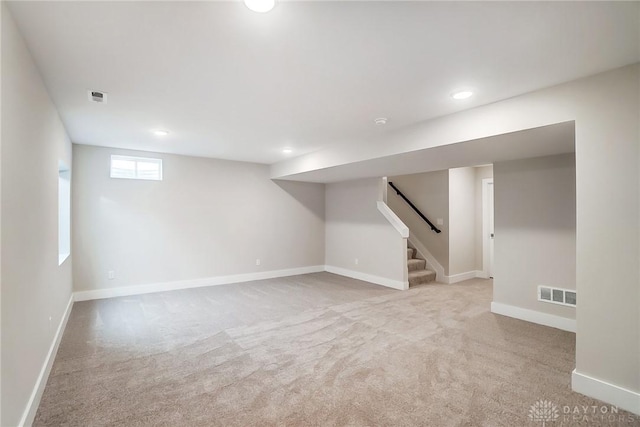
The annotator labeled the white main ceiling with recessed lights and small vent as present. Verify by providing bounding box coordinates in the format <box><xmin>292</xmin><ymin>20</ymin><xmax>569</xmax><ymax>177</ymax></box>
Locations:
<box><xmin>10</xmin><ymin>1</ymin><xmax>640</xmax><ymax>163</ymax></box>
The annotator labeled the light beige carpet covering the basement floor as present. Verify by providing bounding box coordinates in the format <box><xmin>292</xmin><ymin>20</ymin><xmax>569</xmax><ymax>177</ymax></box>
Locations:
<box><xmin>35</xmin><ymin>273</ymin><xmax>640</xmax><ymax>427</ymax></box>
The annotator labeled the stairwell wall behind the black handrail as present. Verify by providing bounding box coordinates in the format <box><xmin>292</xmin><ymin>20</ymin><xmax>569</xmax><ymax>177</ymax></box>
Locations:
<box><xmin>387</xmin><ymin>170</ymin><xmax>449</xmax><ymax>274</ymax></box>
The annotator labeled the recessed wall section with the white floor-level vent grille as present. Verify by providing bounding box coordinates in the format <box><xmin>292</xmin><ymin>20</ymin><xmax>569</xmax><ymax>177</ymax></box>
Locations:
<box><xmin>493</xmin><ymin>154</ymin><xmax>576</xmax><ymax>319</ymax></box>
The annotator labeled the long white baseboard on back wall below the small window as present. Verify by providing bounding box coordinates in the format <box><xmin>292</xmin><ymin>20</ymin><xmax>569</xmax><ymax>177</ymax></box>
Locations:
<box><xmin>74</xmin><ymin>265</ymin><xmax>325</xmax><ymax>301</ymax></box>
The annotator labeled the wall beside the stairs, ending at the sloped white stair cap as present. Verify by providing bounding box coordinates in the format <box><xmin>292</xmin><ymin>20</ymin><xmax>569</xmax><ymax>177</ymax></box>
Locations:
<box><xmin>325</xmin><ymin>179</ymin><xmax>407</xmax><ymax>288</ymax></box>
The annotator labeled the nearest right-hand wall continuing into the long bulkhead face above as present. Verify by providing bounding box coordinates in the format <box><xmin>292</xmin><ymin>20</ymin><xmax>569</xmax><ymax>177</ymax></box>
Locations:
<box><xmin>272</xmin><ymin>64</ymin><xmax>640</xmax><ymax>413</ymax></box>
